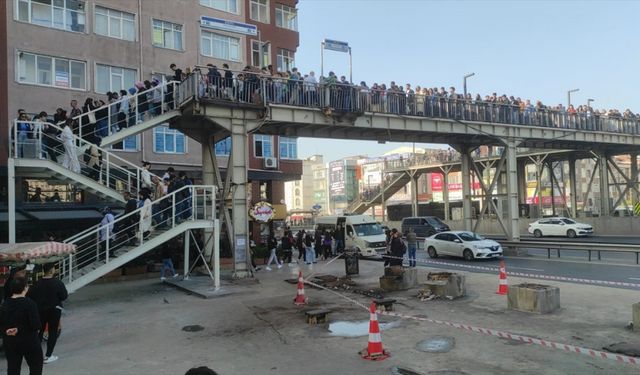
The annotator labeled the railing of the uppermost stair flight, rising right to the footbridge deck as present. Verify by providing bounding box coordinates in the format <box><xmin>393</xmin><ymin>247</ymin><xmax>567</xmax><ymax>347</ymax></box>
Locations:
<box><xmin>58</xmin><ymin>81</ymin><xmax>180</xmax><ymax>143</ymax></box>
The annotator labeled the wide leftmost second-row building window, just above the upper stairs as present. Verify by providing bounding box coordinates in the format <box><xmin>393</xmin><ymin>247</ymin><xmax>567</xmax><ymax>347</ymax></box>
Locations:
<box><xmin>18</xmin><ymin>52</ymin><xmax>87</xmax><ymax>90</ymax></box>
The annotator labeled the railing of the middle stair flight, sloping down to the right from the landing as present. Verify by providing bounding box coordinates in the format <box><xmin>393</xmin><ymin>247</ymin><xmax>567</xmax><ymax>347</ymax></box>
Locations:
<box><xmin>9</xmin><ymin>120</ymin><xmax>159</xmax><ymax>195</ymax></box>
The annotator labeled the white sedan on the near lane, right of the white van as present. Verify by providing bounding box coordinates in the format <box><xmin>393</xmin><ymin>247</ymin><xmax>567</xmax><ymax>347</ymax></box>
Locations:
<box><xmin>424</xmin><ymin>231</ymin><xmax>502</xmax><ymax>260</ymax></box>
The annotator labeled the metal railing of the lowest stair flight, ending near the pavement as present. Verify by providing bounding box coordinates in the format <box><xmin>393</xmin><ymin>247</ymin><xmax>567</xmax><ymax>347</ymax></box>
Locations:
<box><xmin>58</xmin><ymin>185</ymin><xmax>217</xmax><ymax>290</ymax></box>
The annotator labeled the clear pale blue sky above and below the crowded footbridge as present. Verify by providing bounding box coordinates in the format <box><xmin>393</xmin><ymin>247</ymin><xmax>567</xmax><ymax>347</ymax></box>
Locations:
<box><xmin>296</xmin><ymin>0</ymin><xmax>640</xmax><ymax>161</ymax></box>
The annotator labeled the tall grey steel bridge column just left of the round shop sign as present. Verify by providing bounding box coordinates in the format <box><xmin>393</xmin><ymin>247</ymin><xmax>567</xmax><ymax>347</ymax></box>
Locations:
<box><xmin>227</xmin><ymin>118</ymin><xmax>251</xmax><ymax>278</ymax></box>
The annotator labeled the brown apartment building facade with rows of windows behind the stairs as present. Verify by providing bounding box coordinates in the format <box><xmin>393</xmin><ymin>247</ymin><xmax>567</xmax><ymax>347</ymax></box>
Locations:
<box><xmin>0</xmin><ymin>0</ymin><xmax>302</xmax><ymax>241</ymax></box>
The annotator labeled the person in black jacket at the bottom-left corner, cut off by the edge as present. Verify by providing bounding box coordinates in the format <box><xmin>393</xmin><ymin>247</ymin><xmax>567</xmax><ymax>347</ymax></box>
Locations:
<box><xmin>0</xmin><ymin>277</ymin><xmax>44</xmax><ymax>375</ymax></box>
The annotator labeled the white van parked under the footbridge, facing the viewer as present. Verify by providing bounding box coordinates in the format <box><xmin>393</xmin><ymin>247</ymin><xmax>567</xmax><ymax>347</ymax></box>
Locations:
<box><xmin>316</xmin><ymin>215</ymin><xmax>387</xmax><ymax>256</ymax></box>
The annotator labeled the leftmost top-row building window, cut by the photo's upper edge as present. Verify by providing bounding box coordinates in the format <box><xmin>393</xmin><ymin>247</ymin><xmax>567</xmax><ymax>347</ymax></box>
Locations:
<box><xmin>16</xmin><ymin>0</ymin><xmax>85</xmax><ymax>33</ymax></box>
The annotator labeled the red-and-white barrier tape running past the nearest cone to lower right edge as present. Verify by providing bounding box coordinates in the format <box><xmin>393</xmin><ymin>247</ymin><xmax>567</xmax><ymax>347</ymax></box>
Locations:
<box><xmin>304</xmin><ymin>280</ymin><xmax>640</xmax><ymax>366</ymax></box>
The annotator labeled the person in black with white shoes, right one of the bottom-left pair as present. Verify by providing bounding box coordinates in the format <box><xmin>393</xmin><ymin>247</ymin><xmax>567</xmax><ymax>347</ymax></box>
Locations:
<box><xmin>27</xmin><ymin>263</ymin><xmax>69</xmax><ymax>363</ymax></box>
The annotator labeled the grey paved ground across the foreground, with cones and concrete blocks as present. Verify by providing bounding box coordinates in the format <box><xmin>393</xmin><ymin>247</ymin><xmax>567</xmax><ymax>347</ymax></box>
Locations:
<box><xmin>0</xmin><ymin>260</ymin><xmax>640</xmax><ymax>375</ymax></box>
